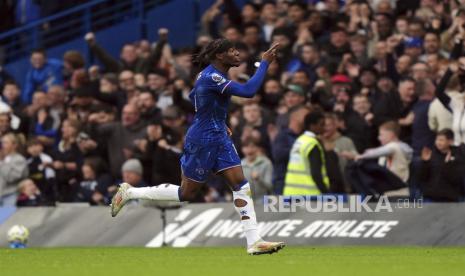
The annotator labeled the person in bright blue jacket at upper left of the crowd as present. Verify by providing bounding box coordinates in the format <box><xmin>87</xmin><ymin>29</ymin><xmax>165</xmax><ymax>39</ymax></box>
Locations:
<box><xmin>21</xmin><ymin>50</ymin><xmax>63</xmax><ymax>104</ymax></box>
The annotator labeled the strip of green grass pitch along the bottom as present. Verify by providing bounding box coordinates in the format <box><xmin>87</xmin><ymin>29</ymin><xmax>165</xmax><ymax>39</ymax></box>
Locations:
<box><xmin>0</xmin><ymin>247</ymin><xmax>465</xmax><ymax>276</ymax></box>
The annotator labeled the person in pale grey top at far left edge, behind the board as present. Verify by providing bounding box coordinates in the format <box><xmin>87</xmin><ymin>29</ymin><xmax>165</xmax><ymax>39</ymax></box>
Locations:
<box><xmin>0</xmin><ymin>133</ymin><xmax>29</xmax><ymax>206</ymax></box>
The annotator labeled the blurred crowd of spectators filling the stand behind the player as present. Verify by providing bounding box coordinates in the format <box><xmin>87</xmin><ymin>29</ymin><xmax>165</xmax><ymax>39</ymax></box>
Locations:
<box><xmin>0</xmin><ymin>0</ymin><xmax>465</xmax><ymax>206</ymax></box>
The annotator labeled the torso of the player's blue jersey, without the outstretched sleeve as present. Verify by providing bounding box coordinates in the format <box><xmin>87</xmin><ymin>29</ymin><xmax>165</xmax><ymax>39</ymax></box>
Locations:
<box><xmin>186</xmin><ymin>65</ymin><xmax>231</xmax><ymax>144</ymax></box>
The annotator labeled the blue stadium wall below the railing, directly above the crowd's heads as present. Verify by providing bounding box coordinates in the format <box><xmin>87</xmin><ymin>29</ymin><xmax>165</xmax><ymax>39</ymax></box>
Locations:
<box><xmin>5</xmin><ymin>0</ymin><xmax>245</xmax><ymax>88</ymax></box>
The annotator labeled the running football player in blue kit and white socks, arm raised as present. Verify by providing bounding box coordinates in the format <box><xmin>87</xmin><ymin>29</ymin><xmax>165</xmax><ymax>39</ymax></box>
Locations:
<box><xmin>111</xmin><ymin>39</ymin><xmax>284</xmax><ymax>255</ymax></box>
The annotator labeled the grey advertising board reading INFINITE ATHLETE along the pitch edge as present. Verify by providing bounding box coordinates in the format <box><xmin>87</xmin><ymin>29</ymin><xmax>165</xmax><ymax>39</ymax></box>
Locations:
<box><xmin>0</xmin><ymin>202</ymin><xmax>465</xmax><ymax>247</ymax></box>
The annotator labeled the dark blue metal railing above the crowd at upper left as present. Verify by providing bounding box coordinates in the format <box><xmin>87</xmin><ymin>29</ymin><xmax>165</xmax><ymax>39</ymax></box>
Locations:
<box><xmin>0</xmin><ymin>0</ymin><xmax>169</xmax><ymax>64</ymax></box>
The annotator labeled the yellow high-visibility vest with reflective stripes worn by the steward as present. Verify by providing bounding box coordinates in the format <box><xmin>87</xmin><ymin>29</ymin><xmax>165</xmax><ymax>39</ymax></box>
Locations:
<box><xmin>283</xmin><ymin>131</ymin><xmax>329</xmax><ymax>195</ymax></box>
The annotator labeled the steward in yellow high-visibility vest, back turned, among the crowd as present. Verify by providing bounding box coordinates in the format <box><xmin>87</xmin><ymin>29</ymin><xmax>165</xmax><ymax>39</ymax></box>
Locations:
<box><xmin>283</xmin><ymin>112</ymin><xmax>329</xmax><ymax>195</ymax></box>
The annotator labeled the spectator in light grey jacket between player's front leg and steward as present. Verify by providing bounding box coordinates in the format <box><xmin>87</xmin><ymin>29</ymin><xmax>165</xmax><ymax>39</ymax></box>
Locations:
<box><xmin>242</xmin><ymin>138</ymin><xmax>273</xmax><ymax>200</ymax></box>
